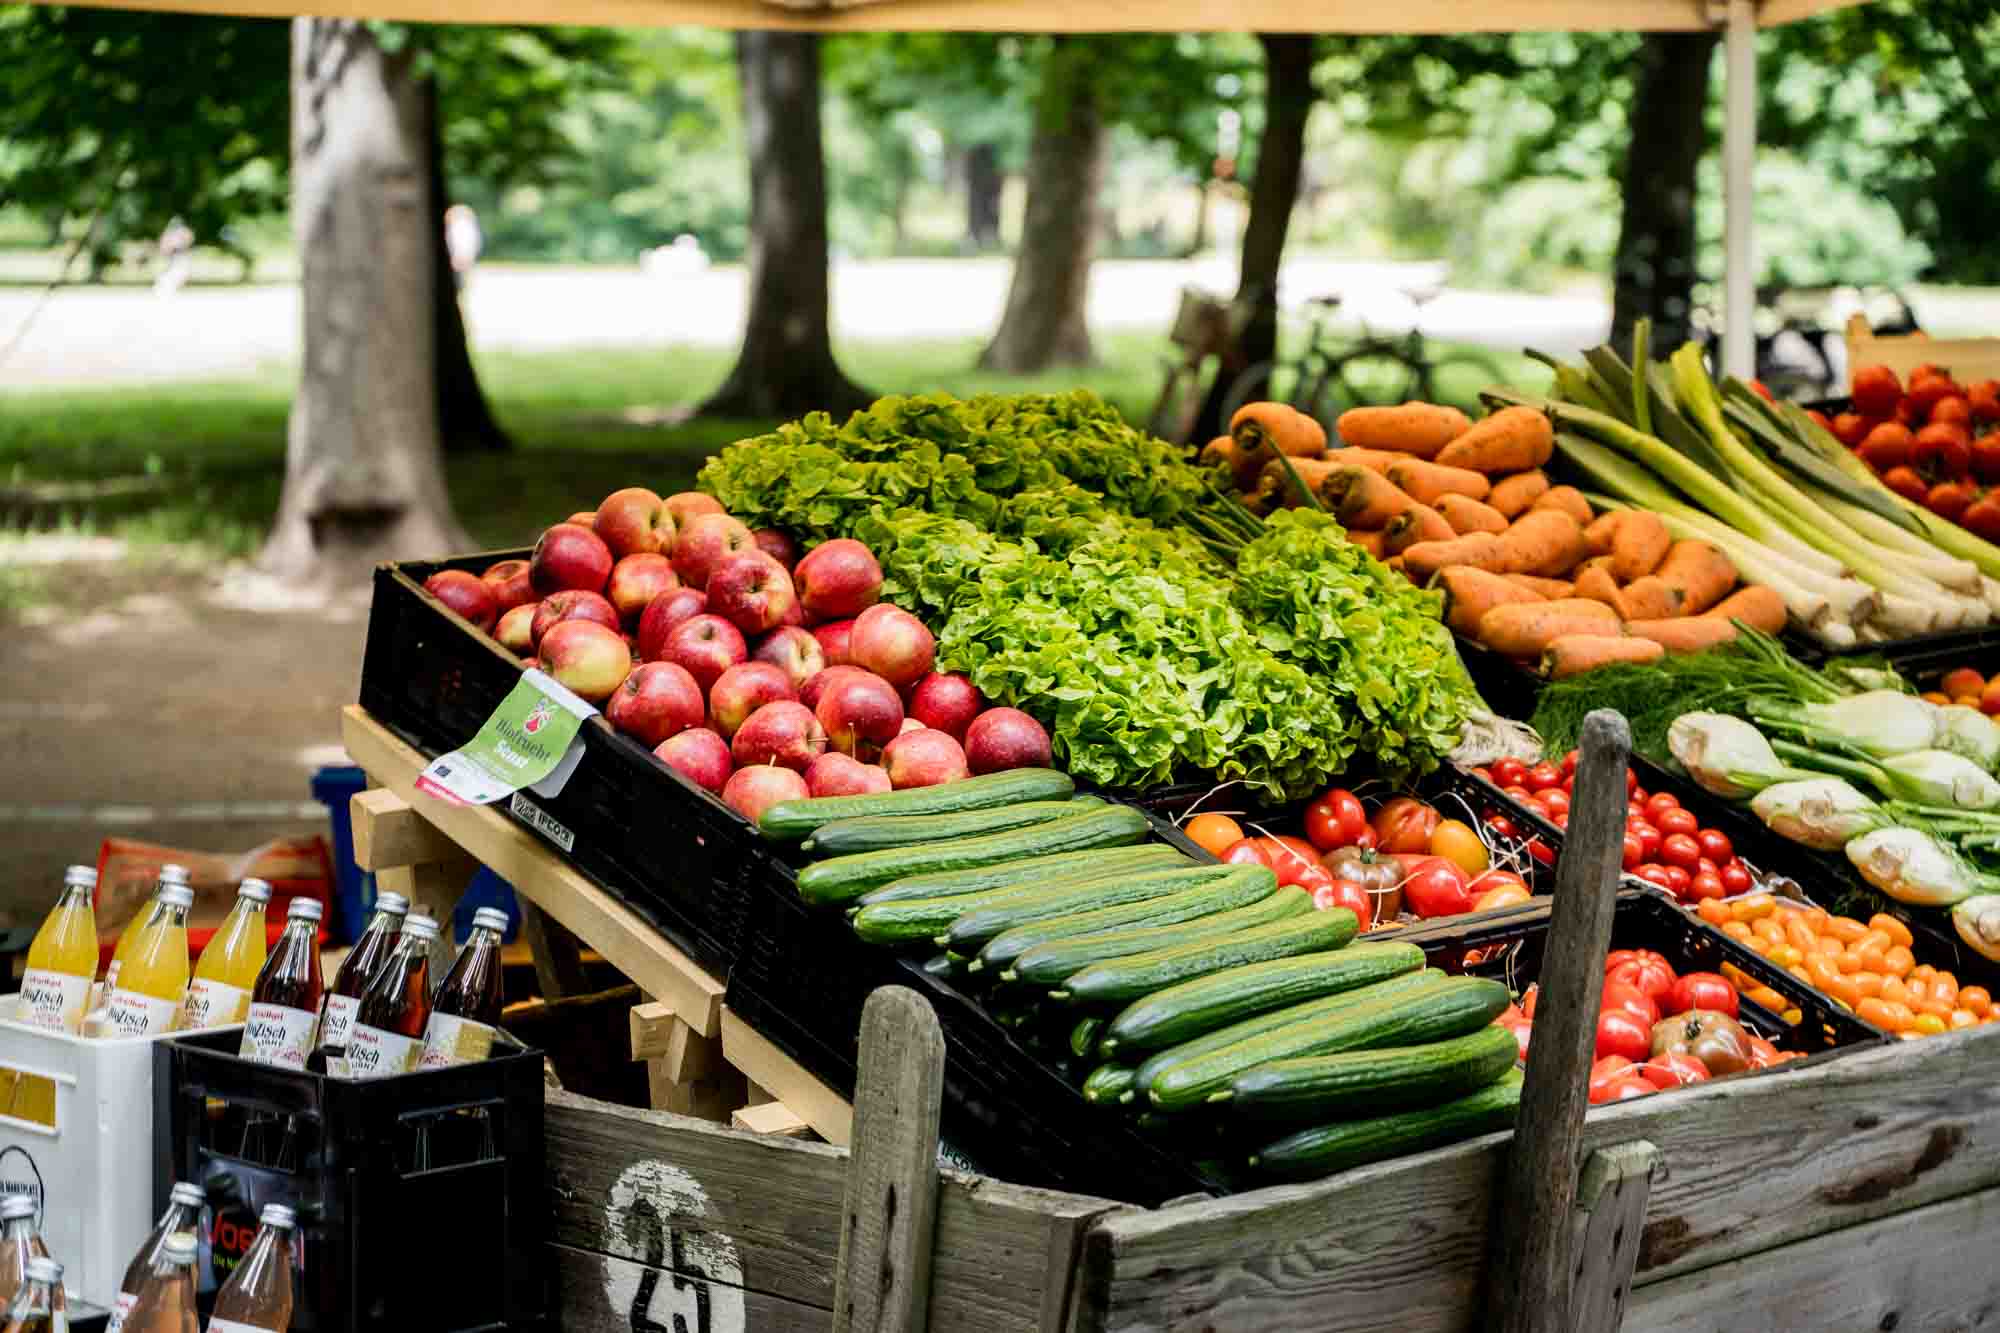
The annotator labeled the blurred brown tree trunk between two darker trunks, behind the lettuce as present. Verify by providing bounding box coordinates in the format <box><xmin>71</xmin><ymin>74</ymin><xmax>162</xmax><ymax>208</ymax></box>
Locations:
<box><xmin>980</xmin><ymin>36</ymin><xmax>1108</xmax><ymax>374</ymax></box>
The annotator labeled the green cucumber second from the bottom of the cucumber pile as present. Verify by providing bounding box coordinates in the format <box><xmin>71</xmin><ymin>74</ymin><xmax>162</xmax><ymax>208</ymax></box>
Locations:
<box><xmin>1230</xmin><ymin>1023</ymin><xmax>1520</xmax><ymax>1123</ymax></box>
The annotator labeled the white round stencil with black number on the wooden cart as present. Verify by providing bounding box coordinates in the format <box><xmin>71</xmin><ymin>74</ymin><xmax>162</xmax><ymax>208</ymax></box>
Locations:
<box><xmin>604</xmin><ymin>1161</ymin><xmax>748</xmax><ymax>1333</ymax></box>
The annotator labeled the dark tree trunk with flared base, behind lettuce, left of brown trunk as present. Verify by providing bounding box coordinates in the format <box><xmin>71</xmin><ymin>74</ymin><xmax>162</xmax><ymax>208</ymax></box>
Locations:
<box><xmin>700</xmin><ymin>32</ymin><xmax>870</xmax><ymax>416</ymax></box>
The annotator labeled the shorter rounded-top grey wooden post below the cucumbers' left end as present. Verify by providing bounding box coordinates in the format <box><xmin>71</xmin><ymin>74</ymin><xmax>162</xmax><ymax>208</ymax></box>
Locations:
<box><xmin>834</xmin><ymin>987</ymin><xmax>944</xmax><ymax>1333</ymax></box>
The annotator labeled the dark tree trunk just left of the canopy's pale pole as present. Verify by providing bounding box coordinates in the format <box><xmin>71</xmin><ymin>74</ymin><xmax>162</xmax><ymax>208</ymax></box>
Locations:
<box><xmin>1612</xmin><ymin>32</ymin><xmax>1716</xmax><ymax>350</ymax></box>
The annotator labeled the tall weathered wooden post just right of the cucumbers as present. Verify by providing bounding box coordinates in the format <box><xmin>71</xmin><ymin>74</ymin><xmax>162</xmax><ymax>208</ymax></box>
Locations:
<box><xmin>1486</xmin><ymin>709</ymin><xmax>1632</xmax><ymax>1333</ymax></box>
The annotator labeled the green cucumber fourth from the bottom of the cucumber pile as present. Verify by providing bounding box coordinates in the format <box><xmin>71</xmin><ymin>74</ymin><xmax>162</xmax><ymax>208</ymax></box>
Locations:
<box><xmin>1102</xmin><ymin>945</ymin><xmax>1424</xmax><ymax>1057</ymax></box>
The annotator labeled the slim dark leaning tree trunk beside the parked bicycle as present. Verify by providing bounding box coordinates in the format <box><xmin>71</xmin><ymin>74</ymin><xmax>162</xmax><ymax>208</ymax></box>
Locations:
<box><xmin>1194</xmin><ymin>32</ymin><xmax>1316</xmax><ymax>440</ymax></box>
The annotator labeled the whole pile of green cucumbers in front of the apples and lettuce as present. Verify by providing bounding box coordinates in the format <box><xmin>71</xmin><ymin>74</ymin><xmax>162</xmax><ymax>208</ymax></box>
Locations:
<box><xmin>760</xmin><ymin>769</ymin><xmax>1520</xmax><ymax>1179</ymax></box>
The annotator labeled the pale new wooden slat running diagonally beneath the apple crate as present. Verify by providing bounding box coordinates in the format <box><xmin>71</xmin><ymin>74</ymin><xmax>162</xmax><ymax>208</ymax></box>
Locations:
<box><xmin>340</xmin><ymin>705</ymin><xmax>724</xmax><ymax>1037</ymax></box>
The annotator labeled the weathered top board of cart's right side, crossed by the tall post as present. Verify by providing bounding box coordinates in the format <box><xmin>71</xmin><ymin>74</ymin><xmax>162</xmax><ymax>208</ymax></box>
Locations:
<box><xmin>1080</xmin><ymin>1029</ymin><xmax>2000</xmax><ymax>1333</ymax></box>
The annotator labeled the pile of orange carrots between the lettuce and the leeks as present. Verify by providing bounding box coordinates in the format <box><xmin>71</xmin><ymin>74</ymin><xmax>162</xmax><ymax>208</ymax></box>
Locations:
<box><xmin>1202</xmin><ymin>402</ymin><xmax>1786</xmax><ymax>679</ymax></box>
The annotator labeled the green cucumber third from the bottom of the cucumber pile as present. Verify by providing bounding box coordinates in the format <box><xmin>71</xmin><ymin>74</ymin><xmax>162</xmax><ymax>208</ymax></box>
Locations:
<box><xmin>1146</xmin><ymin>964</ymin><xmax>1510</xmax><ymax>1111</ymax></box>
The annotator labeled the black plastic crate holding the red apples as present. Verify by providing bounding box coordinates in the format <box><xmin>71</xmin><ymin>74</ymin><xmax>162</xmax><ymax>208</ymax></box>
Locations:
<box><xmin>360</xmin><ymin>550</ymin><xmax>764</xmax><ymax>975</ymax></box>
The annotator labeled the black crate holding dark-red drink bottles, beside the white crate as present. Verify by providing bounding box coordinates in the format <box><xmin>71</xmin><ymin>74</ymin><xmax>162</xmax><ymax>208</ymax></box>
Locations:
<box><xmin>154</xmin><ymin>1033</ymin><xmax>552</xmax><ymax>1333</ymax></box>
